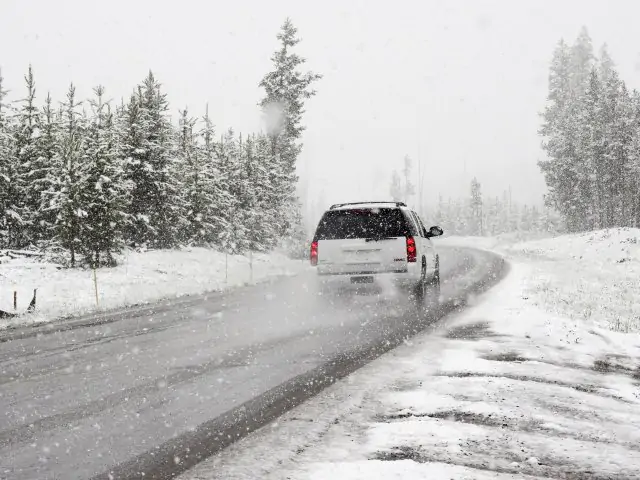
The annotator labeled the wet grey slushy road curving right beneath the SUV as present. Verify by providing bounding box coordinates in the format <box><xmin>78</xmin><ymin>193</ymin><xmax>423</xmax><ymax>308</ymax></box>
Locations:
<box><xmin>0</xmin><ymin>248</ymin><xmax>505</xmax><ymax>479</ymax></box>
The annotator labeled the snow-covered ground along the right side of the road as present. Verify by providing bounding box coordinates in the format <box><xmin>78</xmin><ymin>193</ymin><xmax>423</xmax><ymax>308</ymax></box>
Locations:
<box><xmin>182</xmin><ymin>230</ymin><xmax>640</xmax><ymax>480</ymax></box>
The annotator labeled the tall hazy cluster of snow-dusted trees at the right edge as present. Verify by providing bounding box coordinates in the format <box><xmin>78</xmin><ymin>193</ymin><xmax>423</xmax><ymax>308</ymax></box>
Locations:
<box><xmin>539</xmin><ymin>27</ymin><xmax>640</xmax><ymax>232</ymax></box>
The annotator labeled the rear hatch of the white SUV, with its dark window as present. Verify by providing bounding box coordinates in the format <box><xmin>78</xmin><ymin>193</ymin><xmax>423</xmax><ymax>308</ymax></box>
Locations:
<box><xmin>315</xmin><ymin>208</ymin><xmax>407</xmax><ymax>274</ymax></box>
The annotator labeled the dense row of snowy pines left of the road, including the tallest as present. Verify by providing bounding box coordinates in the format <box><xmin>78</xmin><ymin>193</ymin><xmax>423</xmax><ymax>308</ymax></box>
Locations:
<box><xmin>0</xmin><ymin>20</ymin><xmax>321</xmax><ymax>266</ymax></box>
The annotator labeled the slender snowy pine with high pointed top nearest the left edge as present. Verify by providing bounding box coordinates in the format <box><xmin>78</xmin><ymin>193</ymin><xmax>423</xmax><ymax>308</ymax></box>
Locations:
<box><xmin>13</xmin><ymin>65</ymin><xmax>41</xmax><ymax>248</ymax></box>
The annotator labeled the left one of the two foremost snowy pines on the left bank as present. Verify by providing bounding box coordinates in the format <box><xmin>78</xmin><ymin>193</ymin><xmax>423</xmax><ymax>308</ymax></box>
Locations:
<box><xmin>50</xmin><ymin>84</ymin><xmax>87</xmax><ymax>266</ymax></box>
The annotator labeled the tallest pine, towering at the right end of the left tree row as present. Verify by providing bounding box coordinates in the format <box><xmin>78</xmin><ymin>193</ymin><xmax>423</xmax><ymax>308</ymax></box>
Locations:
<box><xmin>259</xmin><ymin>18</ymin><xmax>322</xmax><ymax>248</ymax></box>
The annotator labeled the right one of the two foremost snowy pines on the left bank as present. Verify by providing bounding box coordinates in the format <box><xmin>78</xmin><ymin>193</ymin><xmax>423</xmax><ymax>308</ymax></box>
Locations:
<box><xmin>80</xmin><ymin>86</ymin><xmax>130</xmax><ymax>267</ymax></box>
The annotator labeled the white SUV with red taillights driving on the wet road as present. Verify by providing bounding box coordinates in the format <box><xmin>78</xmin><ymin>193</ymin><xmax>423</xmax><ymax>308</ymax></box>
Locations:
<box><xmin>310</xmin><ymin>202</ymin><xmax>443</xmax><ymax>301</ymax></box>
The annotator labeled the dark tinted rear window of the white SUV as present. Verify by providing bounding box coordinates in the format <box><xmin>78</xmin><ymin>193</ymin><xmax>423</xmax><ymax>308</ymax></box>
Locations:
<box><xmin>315</xmin><ymin>208</ymin><xmax>410</xmax><ymax>240</ymax></box>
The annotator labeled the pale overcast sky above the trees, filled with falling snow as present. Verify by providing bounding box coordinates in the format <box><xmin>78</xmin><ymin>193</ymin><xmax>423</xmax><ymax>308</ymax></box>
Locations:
<box><xmin>0</xmin><ymin>0</ymin><xmax>640</xmax><ymax>223</ymax></box>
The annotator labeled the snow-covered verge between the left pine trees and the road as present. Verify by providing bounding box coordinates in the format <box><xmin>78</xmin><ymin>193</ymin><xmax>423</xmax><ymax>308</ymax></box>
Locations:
<box><xmin>0</xmin><ymin>248</ymin><xmax>308</xmax><ymax>329</ymax></box>
